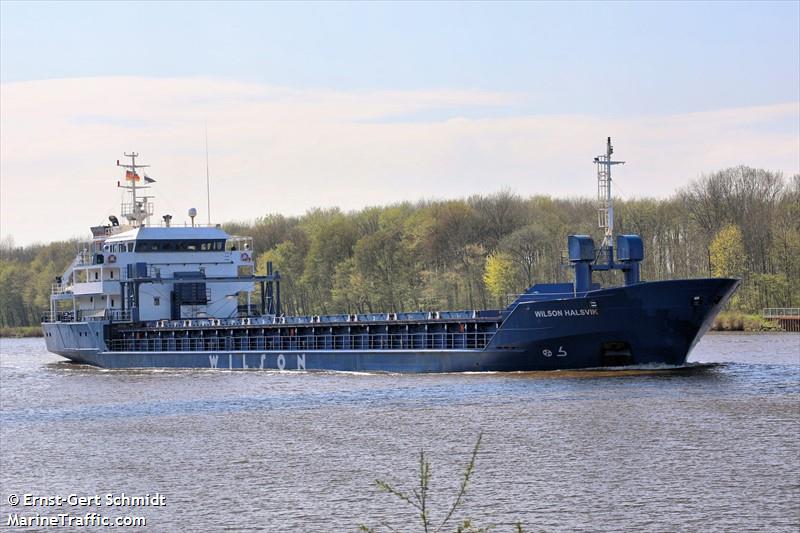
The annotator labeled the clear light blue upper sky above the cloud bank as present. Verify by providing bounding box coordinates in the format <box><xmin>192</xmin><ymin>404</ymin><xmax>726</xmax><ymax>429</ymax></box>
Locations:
<box><xmin>0</xmin><ymin>2</ymin><xmax>800</xmax><ymax>114</ymax></box>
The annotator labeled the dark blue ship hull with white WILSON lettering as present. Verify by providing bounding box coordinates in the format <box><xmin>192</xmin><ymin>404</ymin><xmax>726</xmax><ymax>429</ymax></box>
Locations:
<box><xmin>43</xmin><ymin>279</ymin><xmax>739</xmax><ymax>373</ymax></box>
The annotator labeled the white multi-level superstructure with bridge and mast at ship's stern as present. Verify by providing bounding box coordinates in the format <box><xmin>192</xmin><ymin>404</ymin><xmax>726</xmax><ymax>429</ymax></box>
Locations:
<box><xmin>50</xmin><ymin>153</ymin><xmax>264</xmax><ymax>322</ymax></box>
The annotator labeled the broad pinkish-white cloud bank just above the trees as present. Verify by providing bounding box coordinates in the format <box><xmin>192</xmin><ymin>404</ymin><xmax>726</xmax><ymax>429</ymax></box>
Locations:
<box><xmin>0</xmin><ymin>77</ymin><xmax>800</xmax><ymax>243</ymax></box>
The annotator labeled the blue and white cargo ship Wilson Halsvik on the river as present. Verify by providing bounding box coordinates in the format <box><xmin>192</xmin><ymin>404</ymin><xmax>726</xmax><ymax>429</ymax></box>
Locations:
<box><xmin>42</xmin><ymin>138</ymin><xmax>739</xmax><ymax>373</ymax></box>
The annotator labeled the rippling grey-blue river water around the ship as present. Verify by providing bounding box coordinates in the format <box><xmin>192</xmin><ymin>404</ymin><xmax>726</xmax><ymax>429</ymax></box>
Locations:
<box><xmin>0</xmin><ymin>334</ymin><xmax>800</xmax><ymax>532</ymax></box>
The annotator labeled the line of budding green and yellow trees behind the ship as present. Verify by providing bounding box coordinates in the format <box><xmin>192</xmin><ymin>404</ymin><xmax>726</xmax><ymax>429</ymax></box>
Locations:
<box><xmin>0</xmin><ymin>166</ymin><xmax>800</xmax><ymax>327</ymax></box>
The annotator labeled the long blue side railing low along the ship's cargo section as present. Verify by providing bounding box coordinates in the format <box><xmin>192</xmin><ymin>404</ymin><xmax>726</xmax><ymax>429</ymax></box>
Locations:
<box><xmin>107</xmin><ymin>332</ymin><xmax>494</xmax><ymax>352</ymax></box>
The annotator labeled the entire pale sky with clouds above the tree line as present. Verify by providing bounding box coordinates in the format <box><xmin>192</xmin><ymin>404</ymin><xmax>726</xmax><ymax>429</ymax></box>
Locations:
<box><xmin>0</xmin><ymin>0</ymin><xmax>800</xmax><ymax>245</ymax></box>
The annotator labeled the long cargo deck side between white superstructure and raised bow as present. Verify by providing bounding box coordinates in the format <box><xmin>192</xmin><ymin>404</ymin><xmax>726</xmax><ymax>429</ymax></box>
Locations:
<box><xmin>106</xmin><ymin>310</ymin><xmax>505</xmax><ymax>352</ymax></box>
